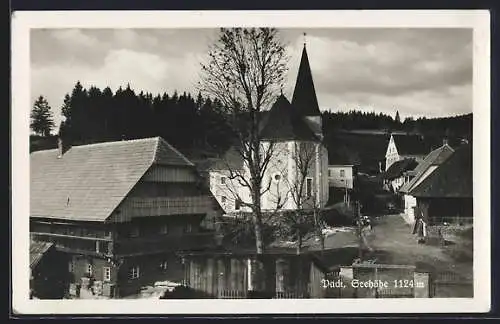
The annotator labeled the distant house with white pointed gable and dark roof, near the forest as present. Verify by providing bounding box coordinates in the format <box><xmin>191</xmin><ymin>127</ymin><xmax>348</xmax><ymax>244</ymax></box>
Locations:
<box><xmin>385</xmin><ymin>134</ymin><xmax>434</xmax><ymax>171</ymax></box>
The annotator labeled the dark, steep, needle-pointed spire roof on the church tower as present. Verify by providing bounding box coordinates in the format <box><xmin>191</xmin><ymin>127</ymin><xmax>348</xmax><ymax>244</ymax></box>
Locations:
<box><xmin>292</xmin><ymin>45</ymin><xmax>320</xmax><ymax>116</ymax></box>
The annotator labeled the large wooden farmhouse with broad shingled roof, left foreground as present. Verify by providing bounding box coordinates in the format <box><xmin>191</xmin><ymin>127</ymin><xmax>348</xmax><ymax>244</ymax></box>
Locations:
<box><xmin>30</xmin><ymin>137</ymin><xmax>216</xmax><ymax>297</ymax></box>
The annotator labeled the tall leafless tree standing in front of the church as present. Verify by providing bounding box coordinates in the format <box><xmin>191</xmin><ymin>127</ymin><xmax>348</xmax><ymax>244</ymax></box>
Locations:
<box><xmin>200</xmin><ymin>28</ymin><xmax>287</xmax><ymax>254</ymax></box>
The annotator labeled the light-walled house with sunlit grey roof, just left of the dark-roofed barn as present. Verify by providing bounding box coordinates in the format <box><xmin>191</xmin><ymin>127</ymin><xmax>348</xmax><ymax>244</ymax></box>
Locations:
<box><xmin>399</xmin><ymin>142</ymin><xmax>454</xmax><ymax>222</ymax></box>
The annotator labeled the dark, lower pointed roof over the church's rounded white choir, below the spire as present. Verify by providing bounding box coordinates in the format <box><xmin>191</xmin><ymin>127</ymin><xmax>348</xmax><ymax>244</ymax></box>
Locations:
<box><xmin>260</xmin><ymin>94</ymin><xmax>319</xmax><ymax>141</ymax></box>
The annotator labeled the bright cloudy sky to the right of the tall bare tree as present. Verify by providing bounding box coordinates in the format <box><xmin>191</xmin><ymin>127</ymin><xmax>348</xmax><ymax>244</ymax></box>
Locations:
<box><xmin>287</xmin><ymin>29</ymin><xmax>472</xmax><ymax>116</ymax></box>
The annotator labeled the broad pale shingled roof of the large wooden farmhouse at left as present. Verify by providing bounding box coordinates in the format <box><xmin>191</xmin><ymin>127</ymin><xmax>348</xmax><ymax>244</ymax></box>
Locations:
<box><xmin>30</xmin><ymin>137</ymin><xmax>194</xmax><ymax>221</ymax></box>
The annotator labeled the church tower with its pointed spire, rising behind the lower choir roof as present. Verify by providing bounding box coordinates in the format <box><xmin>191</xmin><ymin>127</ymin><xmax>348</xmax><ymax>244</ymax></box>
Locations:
<box><xmin>292</xmin><ymin>43</ymin><xmax>323</xmax><ymax>139</ymax></box>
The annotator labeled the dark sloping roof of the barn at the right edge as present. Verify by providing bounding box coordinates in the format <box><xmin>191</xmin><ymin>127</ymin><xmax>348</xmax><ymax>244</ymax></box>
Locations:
<box><xmin>410</xmin><ymin>144</ymin><xmax>473</xmax><ymax>198</ymax></box>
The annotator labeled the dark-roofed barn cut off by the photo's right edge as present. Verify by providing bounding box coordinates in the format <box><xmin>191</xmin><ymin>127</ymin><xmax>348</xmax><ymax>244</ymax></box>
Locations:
<box><xmin>409</xmin><ymin>144</ymin><xmax>473</xmax><ymax>225</ymax></box>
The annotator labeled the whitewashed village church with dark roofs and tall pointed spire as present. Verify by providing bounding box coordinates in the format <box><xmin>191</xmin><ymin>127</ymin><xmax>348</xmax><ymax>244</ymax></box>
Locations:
<box><xmin>206</xmin><ymin>44</ymin><xmax>329</xmax><ymax>214</ymax></box>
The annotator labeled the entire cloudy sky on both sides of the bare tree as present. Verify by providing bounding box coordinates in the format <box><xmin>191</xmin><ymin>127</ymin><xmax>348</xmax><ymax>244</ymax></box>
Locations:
<box><xmin>30</xmin><ymin>28</ymin><xmax>473</xmax><ymax>128</ymax></box>
